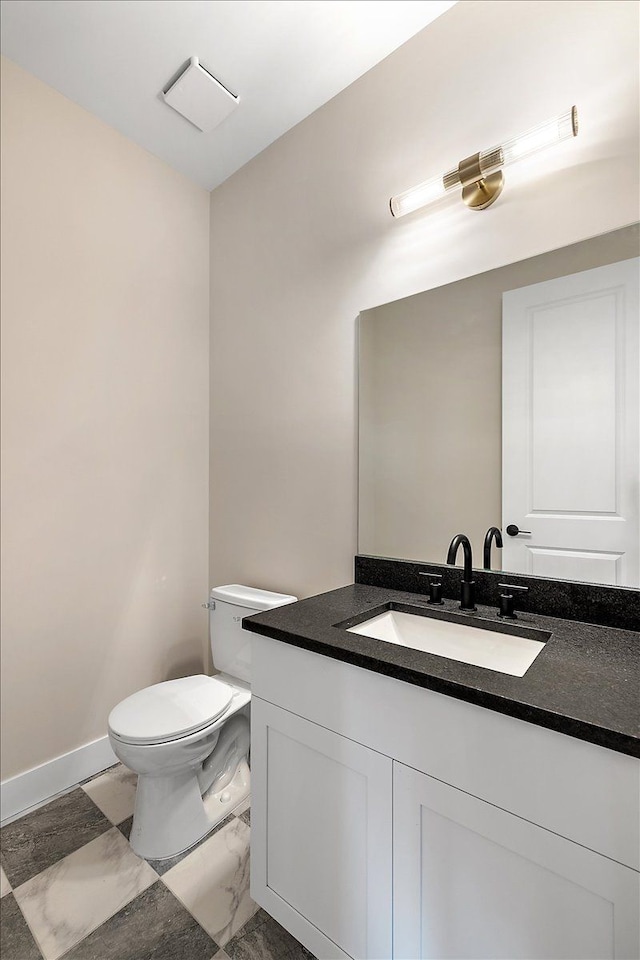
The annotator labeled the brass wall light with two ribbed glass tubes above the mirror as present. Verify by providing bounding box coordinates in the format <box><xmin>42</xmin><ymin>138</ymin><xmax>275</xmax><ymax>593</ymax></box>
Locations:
<box><xmin>389</xmin><ymin>106</ymin><xmax>578</xmax><ymax>217</ymax></box>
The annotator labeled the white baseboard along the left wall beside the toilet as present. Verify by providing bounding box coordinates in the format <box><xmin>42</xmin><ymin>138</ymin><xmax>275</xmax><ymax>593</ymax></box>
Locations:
<box><xmin>0</xmin><ymin>737</ymin><xmax>118</xmax><ymax>824</ymax></box>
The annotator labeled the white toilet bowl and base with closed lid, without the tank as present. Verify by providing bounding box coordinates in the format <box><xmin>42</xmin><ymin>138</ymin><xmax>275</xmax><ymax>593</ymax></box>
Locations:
<box><xmin>109</xmin><ymin>676</ymin><xmax>251</xmax><ymax>860</ymax></box>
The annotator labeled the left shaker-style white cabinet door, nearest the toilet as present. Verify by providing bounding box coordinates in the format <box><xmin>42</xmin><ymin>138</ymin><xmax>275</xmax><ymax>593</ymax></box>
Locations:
<box><xmin>251</xmin><ymin>697</ymin><xmax>392</xmax><ymax>960</ymax></box>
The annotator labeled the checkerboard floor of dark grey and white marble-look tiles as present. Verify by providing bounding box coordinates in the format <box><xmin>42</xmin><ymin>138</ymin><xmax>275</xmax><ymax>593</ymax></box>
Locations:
<box><xmin>0</xmin><ymin>764</ymin><xmax>314</xmax><ymax>960</ymax></box>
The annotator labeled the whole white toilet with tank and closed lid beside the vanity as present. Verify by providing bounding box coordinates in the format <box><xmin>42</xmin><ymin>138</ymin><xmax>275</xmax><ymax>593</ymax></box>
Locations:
<box><xmin>109</xmin><ymin>583</ymin><xmax>297</xmax><ymax>860</ymax></box>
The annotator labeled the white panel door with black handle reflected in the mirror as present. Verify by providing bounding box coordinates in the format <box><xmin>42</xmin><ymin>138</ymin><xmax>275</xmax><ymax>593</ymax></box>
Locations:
<box><xmin>502</xmin><ymin>259</ymin><xmax>640</xmax><ymax>587</ymax></box>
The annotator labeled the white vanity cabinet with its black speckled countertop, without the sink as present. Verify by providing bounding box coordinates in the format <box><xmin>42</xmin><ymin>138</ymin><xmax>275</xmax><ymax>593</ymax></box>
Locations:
<box><xmin>244</xmin><ymin>570</ymin><xmax>640</xmax><ymax>960</ymax></box>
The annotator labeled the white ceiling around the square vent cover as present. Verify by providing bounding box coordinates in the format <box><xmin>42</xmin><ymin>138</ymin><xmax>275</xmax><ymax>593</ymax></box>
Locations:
<box><xmin>1</xmin><ymin>0</ymin><xmax>455</xmax><ymax>189</ymax></box>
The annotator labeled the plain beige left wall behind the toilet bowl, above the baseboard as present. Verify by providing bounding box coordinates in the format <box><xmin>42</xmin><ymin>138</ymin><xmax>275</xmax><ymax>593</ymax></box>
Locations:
<box><xmin>2</xmin><ymin>60</ymin><xmax>209</xmax><ymax>777</ymax></box>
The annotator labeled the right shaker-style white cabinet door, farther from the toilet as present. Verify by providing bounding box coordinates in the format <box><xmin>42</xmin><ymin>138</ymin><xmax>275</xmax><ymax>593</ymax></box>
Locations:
<box><xmin>393</xmin><ymin>763</ymin><xmax>639</xmax><ymax>960</ymax></box>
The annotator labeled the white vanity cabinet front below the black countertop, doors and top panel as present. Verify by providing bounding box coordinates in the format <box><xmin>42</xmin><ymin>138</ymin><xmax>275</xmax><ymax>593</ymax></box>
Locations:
<box><xmin>251</xmin><ymin>636</ymin><xmax>640</xmax><ymax>960</ymax></box>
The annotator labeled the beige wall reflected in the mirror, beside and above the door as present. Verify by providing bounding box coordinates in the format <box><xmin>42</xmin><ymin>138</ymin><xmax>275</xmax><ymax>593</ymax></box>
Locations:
<box><xmin>358</xmin><ymin>225</ymin><xmax>639</xmax><ymax>569</ymax></box>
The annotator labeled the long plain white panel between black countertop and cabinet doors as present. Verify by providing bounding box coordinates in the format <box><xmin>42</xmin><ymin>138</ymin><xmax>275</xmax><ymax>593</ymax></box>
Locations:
<box><xmin>252</xmin><ymin>635</ymin><xmax>640</xmax><ymax>870</ymax></box>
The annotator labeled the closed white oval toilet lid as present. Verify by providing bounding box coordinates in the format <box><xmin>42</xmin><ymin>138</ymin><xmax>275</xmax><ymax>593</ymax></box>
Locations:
<box><xmin>109</xmin><ymin>675</ymin><xmax>233</xmax><ymax>743</ymax></box>
